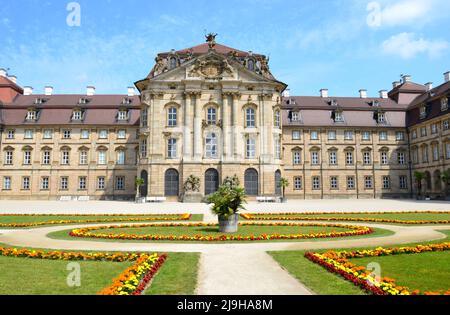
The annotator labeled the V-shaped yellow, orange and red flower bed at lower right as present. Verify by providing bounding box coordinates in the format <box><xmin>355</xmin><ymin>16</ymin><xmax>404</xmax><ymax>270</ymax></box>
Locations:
<box><xmin>305</xmin><ymin>243</ymin><xmax>450</xmax><ymax>295</ymax></box>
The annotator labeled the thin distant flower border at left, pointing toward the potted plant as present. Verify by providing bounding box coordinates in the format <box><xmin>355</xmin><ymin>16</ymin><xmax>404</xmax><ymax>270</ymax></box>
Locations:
<box><xmin>0</xmin><ymin>213</ymin><xmax>192</xmax><ymax>228</ymax></box>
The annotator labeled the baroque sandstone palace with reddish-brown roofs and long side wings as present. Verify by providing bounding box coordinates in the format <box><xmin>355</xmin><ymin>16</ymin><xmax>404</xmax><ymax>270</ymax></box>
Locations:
<box><xmin>0</xmin><ymin>34</ymin><xmax>450</xmax><ymax>201</ymax></box>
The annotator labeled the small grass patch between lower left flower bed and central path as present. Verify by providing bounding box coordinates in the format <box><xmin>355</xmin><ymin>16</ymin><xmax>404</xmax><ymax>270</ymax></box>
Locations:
<box><xmin>145</xmin><ymin>253</ymin><xmax>200</xmax><ymax>295</ymax></box>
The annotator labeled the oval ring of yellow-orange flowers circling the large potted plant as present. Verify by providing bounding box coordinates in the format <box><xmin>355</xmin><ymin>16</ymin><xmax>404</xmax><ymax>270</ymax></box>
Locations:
<box><xmin>69</xmin><ymin>222</ymin><xmax>374</xmax><ymax>242</ymax></box>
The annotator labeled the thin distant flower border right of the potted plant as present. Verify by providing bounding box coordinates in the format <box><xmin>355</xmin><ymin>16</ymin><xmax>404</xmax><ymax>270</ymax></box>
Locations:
<box><xmin>241</xmin><ymin>211</ymin><xmax>450</xmax><ymax>224</ymax></box>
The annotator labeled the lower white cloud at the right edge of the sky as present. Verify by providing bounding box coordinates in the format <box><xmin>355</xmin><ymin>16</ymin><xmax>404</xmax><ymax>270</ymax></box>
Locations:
<box><xmin>381</xmin><ymin>33</ymin><xmax>449</xmax><ymax>59</ymax></box>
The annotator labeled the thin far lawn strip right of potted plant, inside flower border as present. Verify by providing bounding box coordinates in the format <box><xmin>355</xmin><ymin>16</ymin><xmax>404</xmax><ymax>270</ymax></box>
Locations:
<box><xmin>250</xmin><ymin>212</ymin><xmax>450</xmax><ymax>224</ymax></box>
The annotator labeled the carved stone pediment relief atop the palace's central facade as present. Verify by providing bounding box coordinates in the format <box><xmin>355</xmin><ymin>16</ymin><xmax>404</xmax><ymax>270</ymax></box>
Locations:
<box><xmin>188</xmin><ymin>55</ymin><xmax>233</xmax><ymax>79</ymax></box>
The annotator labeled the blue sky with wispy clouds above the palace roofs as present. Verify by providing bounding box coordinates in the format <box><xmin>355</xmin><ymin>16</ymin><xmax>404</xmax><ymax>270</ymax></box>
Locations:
<box><xmin>0</xmin><ymin>0</ymin><xmax>450</xmax><ymax>96</ymax></box>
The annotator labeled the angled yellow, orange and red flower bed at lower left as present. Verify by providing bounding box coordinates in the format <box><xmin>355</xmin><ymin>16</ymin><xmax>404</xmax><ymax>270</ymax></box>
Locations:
<box><xmin>0</xmin><ymin>247</ymin><xmax>167</xmax><ymax>295</ymax></box>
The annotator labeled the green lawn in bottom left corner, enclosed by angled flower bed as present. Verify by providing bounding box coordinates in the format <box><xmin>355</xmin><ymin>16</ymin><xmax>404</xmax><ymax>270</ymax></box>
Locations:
<box><xmin>0</xmin><ymin>256</ymin><xmax>133</xmax><ymax>295</ymax></box>
